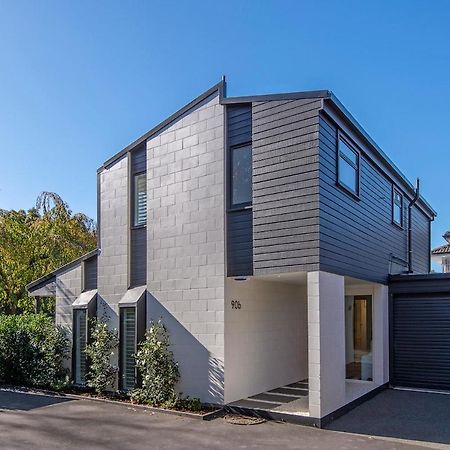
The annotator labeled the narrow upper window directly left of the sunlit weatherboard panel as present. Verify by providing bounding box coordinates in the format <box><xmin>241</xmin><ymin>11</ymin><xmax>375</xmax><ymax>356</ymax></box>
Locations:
<box><xmin>231</xmin><ymin>145</ymin><xmax>252</xmax><ymax>207</ymax></box>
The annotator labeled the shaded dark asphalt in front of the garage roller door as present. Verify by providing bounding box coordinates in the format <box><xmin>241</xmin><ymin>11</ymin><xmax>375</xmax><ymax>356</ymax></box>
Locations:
<box><xmin>326</xmin><ymin>389</ymin><xmax>450</xmax><ymax>444</ymax></box>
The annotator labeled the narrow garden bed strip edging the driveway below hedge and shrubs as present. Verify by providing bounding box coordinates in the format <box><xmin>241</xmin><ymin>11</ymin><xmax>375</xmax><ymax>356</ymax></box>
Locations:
<box><xmin>0</xmin><ymin>385</ymin><xmax>225</xmax><ymax>420</ymax></box>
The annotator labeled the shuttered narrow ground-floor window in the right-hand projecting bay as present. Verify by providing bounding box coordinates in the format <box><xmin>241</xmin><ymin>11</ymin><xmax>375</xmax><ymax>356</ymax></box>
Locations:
<box><xmin>120</xmin><ymin>307</ymin><xmax>136</xmax><ymax>391</ymax></box>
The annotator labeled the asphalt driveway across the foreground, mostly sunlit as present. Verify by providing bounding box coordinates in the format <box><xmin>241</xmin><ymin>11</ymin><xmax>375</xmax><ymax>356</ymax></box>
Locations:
<box><xmin>0</xmin><ymin>391</ymin><xmax>440</xmax><ymax>450</ymax></box>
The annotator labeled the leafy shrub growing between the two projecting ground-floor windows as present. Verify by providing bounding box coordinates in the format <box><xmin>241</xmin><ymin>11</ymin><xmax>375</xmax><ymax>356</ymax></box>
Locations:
<box><xmin>86</xmin><ymin>318</ymin><xmax>119</xmax><ymax>395</ymax></box>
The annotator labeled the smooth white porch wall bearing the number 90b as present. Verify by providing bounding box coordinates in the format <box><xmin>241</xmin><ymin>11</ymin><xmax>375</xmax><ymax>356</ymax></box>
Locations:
<box><xmin>225</xmin><ymin>278</ymin><xmax>308</xmax><ymax>403</ymax></box>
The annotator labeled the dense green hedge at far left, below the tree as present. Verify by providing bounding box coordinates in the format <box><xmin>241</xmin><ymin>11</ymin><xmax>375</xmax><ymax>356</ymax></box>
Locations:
<box><xmin>0</xmin><ymin>314</ymin><xmax>68</xmax><ymax>389</ymax></box>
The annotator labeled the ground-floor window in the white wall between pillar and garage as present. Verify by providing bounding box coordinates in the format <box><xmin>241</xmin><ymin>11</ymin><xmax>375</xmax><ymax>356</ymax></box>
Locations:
<box><xmin>345</xmin><ymin>295</ymin><xmax>373</xmax><ymax>381</ymax></box>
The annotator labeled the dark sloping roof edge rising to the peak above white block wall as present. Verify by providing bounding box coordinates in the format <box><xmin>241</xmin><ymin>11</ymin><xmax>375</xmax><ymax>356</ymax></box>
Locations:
<box><xmin>97</xmin><ymin>78</ymin><xmax>226</xmax><ymax>173</ymax></box>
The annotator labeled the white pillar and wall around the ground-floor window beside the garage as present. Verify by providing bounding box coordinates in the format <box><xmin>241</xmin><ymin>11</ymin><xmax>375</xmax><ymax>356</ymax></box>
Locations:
<box><xmin>307</xmin><ymin>272</ymin><xmax>389</xmax><ymax>417</ymax></box>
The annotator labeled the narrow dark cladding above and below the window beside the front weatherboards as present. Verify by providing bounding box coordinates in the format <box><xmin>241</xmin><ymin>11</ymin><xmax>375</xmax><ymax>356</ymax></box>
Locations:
<box><xmin>226</xmin><ymin>103</ymin><xmax>253</xmax><ymax>276</ymax></box>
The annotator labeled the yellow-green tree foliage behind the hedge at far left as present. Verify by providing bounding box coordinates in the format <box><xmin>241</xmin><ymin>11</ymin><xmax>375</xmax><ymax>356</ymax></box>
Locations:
<box><xmin>0</xmin><ymin>192</ymin><xmax>96</xmax><ymax>314</ymax></box>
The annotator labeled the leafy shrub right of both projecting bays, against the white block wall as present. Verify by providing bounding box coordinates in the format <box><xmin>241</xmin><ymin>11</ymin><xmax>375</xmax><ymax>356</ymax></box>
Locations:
<box><xmin>130</xmin><ymin>321</ymin><xmax>180</xmax><ymax>407</ymax></box>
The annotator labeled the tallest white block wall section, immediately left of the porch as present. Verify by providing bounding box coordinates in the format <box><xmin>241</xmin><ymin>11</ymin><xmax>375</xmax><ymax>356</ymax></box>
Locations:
<box><xmin>147</xmin><ymin>94</ymin><xmax>225</xmax><ymax>403</ymax></box>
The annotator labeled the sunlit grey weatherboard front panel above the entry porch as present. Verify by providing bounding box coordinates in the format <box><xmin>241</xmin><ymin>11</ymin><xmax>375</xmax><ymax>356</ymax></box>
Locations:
<box><xmin>252</xmin><ymin>98</ymin><xmax>322</xmax><ymax>275</ymax></box>
